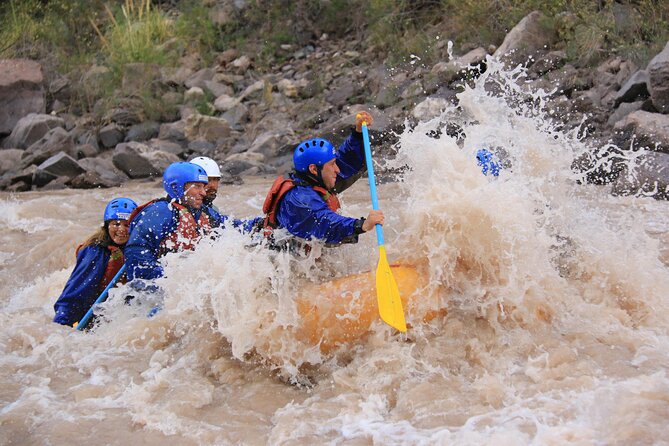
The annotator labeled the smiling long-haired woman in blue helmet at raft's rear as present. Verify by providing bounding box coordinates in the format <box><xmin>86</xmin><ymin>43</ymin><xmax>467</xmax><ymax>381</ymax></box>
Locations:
<box><xmin>53</xmin><ymin>198</ymin><xmax>137</xmax><ymax>325</ymax></box>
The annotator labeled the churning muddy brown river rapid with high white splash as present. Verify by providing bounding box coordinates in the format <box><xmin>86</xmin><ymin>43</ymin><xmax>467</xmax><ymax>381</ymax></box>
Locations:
<box><xmin>0</xmin><ymin>62</ymin><xmax>669</xmax><ymax>446</ymax></box>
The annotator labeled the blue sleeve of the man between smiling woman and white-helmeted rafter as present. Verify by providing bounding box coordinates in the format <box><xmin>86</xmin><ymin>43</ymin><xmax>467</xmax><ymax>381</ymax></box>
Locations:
<box><xmin>124</xmin><ymin>201</ymin><xmax>177</xmax><ymax>280</ymax></box>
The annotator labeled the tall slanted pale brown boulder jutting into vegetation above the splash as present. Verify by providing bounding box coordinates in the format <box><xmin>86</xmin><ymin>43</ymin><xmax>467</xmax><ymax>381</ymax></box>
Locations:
<box><xmin>493</xmin><ymin>11</ymin><xmax>556</xmax><ymax>65</ymax></box>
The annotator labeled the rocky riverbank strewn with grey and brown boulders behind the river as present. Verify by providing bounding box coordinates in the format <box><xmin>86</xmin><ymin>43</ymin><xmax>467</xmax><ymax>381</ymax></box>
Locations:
<box><xmin>0</xmin><ymin>7</ymin><xmax>669</xmax><ymax>199</ymax></box>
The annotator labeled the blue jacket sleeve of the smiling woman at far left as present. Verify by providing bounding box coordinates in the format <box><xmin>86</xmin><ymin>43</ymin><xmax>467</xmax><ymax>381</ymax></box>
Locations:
<box><xmin>53</xmin><ymin>245</ymin><xmax>109</xmax><ymax>325</ymax></box>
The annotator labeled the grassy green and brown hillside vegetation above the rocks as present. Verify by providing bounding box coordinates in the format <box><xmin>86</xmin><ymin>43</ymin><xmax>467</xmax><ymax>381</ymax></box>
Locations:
<box><xmin>0</xmin><ymin>0</ymin><xmax>669</xmax><ymax>113</ymax></box>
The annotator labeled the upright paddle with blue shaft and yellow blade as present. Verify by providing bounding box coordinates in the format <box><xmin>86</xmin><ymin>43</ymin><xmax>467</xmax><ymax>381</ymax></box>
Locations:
<box><xmin>362</xmin><ymin>122</ymin><xmax>407</xmax><ymax>332</ymax></box>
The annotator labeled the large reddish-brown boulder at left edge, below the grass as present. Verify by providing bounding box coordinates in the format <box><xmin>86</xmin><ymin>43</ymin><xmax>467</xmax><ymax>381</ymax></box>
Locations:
<box><xmin>0</xmin><ymin>59</ymin><xmax>46</xmax><ymax>135</ymax></box>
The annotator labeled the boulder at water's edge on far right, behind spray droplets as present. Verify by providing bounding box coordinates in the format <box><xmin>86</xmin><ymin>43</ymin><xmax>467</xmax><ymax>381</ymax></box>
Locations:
<box><xmin>611</xmin><ymin>152</ymin><xmax>669</xmax><ymax>200</ymax></box>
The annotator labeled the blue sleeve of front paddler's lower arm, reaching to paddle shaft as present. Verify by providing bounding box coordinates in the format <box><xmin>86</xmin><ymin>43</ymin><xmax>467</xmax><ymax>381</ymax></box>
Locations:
<box><xmin>277</xmin><ymin>186</ymin><xmax>356</xmax><ymax>244</ymax></box>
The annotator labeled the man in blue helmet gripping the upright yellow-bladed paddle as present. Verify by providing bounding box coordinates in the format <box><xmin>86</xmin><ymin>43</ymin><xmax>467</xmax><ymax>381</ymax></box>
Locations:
<box><xmin>263</xmin><ymin>111</ymin><xmax>384</xmax><ymax>249</ymax></box>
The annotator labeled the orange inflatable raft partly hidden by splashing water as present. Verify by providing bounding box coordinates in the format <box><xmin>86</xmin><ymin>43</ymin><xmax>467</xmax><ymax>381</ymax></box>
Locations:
<box><xmin>297</xmin><ymin>265</ymin><xmax>446</xmax><ymax>354</ymax></box>
